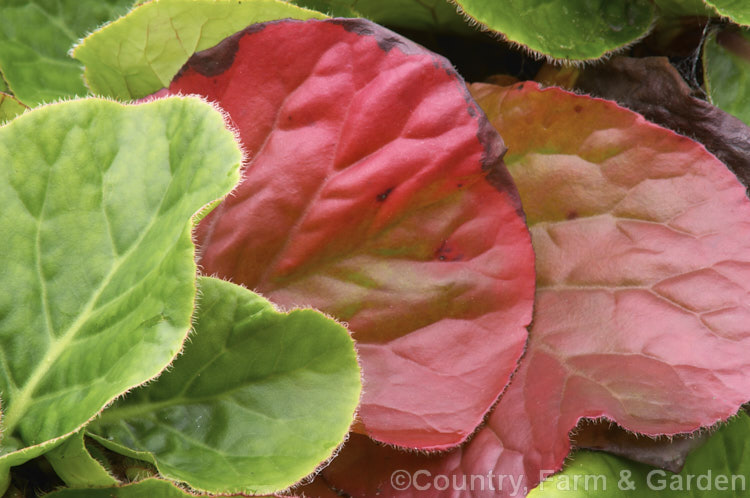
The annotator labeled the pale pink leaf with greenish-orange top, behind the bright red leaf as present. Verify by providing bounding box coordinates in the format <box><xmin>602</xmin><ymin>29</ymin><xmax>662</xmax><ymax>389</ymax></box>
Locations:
<box><xmin>316</xmin><ymin>82</ymin><xmax>750</xmax><ymax>496</ymax></box>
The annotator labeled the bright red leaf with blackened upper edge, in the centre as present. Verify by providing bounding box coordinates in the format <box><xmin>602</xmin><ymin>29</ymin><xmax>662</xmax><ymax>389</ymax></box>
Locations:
<box><xmin>163</xmin><ymin>20</ymin><xmax>534</xmax><ymax>449</ymax></box>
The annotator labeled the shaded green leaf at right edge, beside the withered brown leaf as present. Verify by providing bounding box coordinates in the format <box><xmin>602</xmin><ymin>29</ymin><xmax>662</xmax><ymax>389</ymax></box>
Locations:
<box><xmin>703</xmin><ymin>28</ymin><xmax>750</xmax><ymax>125</ymax></box>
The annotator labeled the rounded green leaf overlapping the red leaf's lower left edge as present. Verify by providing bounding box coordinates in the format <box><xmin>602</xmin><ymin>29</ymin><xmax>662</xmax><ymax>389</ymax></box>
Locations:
<box><xmin>89</xmin><ymin>277</ymin><xmax>360</xmax><ymax>494</ymax></box>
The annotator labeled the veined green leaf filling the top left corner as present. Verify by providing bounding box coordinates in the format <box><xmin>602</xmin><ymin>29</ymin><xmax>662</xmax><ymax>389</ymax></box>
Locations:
<box><xmin>0</xmin><ymin>0</ymin><xmax>132</xmax><ymax>107</ymax></box>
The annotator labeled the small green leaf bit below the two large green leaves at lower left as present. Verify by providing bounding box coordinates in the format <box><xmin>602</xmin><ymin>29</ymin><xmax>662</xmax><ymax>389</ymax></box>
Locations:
<box><xmin>44</xmin><ymin>431</ymin><xmax>119</xmax><ymax>488</ymax></box>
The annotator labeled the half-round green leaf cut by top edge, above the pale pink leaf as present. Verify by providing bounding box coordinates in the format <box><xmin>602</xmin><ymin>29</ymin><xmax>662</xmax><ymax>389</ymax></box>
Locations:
<box><xmin>454</xmin><ymin>0</ymin><xmax>655</xmax><ymax>60</ymax></box>
